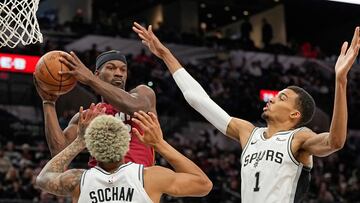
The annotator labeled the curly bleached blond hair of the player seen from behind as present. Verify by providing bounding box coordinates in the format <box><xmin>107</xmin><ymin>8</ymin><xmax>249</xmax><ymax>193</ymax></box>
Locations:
<box><xmin>85</xmin><ymin>115</ymin><xmax>130</xmax><ymax>163</ymax></box>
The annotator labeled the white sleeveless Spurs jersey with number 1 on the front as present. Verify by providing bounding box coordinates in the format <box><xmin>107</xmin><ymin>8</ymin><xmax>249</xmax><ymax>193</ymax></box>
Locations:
<box><xmin>241</xmin><ymin>128</ymin><xmax>310</xmax><ymax>203</ymax></box>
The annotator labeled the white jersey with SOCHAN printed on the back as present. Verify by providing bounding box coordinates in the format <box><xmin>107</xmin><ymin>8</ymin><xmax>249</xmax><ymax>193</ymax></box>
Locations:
<box><xmin>78</xmin><ymin>162</ymin><xmax>152</xmax><ymax>203</ymax></box>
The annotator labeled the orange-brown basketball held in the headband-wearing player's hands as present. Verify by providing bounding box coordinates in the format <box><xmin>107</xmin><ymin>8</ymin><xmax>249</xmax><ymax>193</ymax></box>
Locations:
<box><xmin>34</xmin><ymin>51</ymin><xmax>76</xmax><ymax>95</ymax></box>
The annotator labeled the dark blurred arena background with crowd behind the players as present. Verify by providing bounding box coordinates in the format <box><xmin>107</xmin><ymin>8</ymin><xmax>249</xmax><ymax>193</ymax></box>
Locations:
<box><xmin>0</xmin><ymin>0</ymin><xmax>360</xmax><ymax>203</ymax></box>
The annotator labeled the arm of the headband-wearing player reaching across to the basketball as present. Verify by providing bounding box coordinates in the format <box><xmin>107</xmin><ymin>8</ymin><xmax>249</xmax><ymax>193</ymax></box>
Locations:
<box><xmin>60</xmin><ymin>52</ymin><xmax>156</xmax><ymax>115</ymax></box>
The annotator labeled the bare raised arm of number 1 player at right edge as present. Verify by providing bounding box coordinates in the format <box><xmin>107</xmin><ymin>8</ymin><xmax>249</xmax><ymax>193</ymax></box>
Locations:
<box><xmin>301</xmin><ymin>27</ymin><xmax>360</xmax><ymax>156</ymax></box>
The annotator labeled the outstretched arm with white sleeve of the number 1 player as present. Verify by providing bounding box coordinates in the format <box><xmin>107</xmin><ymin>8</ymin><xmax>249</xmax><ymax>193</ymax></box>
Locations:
<box><xmin>133</xmin><ymin>22</ymin><xmax>254</xmax><ymax>146</ymax></box>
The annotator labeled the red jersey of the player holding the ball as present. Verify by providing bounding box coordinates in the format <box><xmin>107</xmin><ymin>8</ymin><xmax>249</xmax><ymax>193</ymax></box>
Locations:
<box><xmin>88</xmin><ymin>103</ymin><xmax>155</xmax><ymax>167</ymax></box>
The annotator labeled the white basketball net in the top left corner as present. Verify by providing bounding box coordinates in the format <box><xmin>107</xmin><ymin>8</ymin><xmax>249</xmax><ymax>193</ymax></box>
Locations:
<box><xmin>0</xmin><ymin>0</ymin><xmax>43</xmax><ymax>48</ymax></box>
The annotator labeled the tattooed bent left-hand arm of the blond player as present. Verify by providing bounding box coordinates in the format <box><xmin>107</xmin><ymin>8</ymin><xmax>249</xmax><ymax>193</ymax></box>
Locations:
<box><xmin>35</xmin><ymin>104</ymin><xmax>106</xmax><ymax>196</ymax></box>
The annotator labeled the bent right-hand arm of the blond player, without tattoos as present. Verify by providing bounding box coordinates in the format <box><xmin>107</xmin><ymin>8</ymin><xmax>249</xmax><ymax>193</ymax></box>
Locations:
<box><xmin>132</xmin><ymin>111</ymin><xmax>212</xmax><ymax>202</ymax></box>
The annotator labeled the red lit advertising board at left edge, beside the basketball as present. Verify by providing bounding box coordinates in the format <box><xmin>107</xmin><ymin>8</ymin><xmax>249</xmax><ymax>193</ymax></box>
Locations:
<box><xmin>0</xmin><ymin>53</ymin><xmax>40</xmax><ymax>74</ymax></box>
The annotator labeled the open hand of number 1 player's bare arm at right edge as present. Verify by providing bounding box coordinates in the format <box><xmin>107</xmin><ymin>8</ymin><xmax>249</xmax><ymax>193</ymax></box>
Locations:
<box><xmin>335</xmin><ymin>27</ymin><xmax>360</xmax><ymax>78</ymax></box>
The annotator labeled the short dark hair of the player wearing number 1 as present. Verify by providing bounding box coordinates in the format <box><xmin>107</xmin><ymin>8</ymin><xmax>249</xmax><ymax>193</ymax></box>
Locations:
<box><xmin>286</xmin><ymin>86</ymin><xmax>316</xmax><ymax>127</ymax></box>
